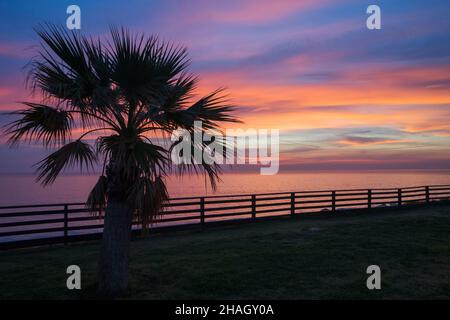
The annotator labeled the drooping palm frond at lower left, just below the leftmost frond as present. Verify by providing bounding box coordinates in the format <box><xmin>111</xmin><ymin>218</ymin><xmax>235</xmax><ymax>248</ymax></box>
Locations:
<box><xmin>37</xmin><ymin>140</ymin><xmax>96</xmax><ymax>186</ymax></box>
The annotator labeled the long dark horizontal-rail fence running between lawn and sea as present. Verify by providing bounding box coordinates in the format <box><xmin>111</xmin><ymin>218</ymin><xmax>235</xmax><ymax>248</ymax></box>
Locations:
<box><xmin>0</xmin><ymin>185</ymin><xmax>450</xmax><ymax>248</ymax></box>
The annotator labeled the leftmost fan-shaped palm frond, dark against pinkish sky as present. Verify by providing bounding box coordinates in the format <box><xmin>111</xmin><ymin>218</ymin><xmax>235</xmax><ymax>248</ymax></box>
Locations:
<box><xmin>6</xmin><ymin>102</ymin><xmax>73</xmax><ymax>145</ymax></box>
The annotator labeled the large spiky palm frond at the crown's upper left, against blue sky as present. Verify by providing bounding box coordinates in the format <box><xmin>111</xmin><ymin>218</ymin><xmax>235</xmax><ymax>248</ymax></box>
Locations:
<box><xmin>28</xmin><ymin>25</ymin><xmax>117</xmax><ymax>125</ymax></box>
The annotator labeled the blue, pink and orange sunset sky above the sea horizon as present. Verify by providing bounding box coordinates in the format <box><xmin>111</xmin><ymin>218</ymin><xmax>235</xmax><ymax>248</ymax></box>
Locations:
<box><xmin>0</xmin><ymin>0</ymin><xmax>450</xmax><ymax>173</ymax></box>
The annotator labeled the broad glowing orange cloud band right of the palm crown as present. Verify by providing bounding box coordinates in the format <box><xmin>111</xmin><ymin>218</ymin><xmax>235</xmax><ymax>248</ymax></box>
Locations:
<box><xmin>193</xmin><ymin>61</ymin><xmax>450</xmax><ymax>131</ymax></box>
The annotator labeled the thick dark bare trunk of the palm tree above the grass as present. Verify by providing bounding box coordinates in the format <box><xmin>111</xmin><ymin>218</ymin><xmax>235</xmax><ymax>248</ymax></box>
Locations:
<box><xmin>98</xmin><ymin>198</ymin><xmax>133</xmax><ymax>296</ymax></box>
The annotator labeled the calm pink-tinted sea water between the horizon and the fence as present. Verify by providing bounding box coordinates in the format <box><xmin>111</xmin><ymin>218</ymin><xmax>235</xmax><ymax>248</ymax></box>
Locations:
<box><xmin>0</xmin><ymin>170</ymin><xmax>450</xmax><ymax>206</ymax></box>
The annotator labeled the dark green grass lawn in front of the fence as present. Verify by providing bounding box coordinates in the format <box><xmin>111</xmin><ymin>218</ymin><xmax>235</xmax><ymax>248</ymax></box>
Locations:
<box><xmin>0</xmin><ymin>206</ymin><xmax>450</xmax><ymax>299</ymax></box>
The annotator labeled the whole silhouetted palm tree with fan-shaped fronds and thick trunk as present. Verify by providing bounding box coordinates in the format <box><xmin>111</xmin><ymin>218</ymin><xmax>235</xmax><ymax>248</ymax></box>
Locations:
<box><xmin>7</xmin><ymin>25</ymin><xmax>238</xmax><ymax>295</ymax></box>
